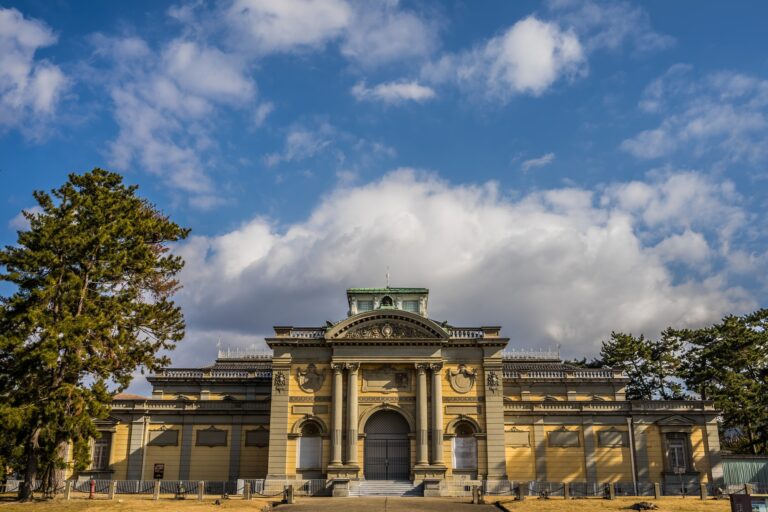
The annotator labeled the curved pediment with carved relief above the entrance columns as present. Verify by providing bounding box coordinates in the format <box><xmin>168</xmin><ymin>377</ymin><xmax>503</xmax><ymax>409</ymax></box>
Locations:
<box><xmin>326</xmin><ymin>311</ymin><xmax>448</xmax><ymax>341</ymax></box>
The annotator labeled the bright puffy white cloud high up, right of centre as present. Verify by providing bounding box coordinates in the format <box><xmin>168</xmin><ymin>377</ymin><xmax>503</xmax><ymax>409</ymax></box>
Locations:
<box><xmin>423</xmin><ymin>16</ymin><xmax>586</xmax><ymax>101</ymax></box>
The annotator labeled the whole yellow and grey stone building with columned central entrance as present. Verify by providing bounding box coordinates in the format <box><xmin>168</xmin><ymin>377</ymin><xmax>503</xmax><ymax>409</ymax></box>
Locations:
<box><xmin>94</xmin><ymin>287</ymin><xmax>722</xmax><ymax>495</ymax></box>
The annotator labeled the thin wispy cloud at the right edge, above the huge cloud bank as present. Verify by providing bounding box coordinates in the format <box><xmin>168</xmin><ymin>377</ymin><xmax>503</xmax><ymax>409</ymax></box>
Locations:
<box><xmin>621</xmin><ymin>65</ymin><xmax>768</xmax><ymax>165</ymax></box>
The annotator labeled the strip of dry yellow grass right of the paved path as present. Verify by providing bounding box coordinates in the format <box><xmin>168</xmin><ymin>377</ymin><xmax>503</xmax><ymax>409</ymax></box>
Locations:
<box><xmin>501</xmin><ymin>496</ymin><xmax>731</xmax><ymax>512</ymax></box>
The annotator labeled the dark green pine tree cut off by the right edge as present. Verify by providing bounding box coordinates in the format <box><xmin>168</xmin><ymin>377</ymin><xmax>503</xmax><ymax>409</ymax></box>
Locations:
<box><xmin>675</xmin><ymin>309</ymin><xmax>768</xmax><ymax>454</ymax></box>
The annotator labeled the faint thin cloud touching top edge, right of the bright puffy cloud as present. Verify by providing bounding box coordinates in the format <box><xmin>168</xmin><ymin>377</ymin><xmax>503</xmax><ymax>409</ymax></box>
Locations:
<box><xmin>548</xmin><ymin>0</ymin><xmax>675</xmax><ymax>52</ymax></box>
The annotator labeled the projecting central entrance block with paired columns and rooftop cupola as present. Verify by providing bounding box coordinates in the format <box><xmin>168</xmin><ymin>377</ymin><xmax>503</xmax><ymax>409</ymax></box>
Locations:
<box><xmin>267</xmin><ymin>289</ymin><xmax>508</xmax><ymax>483</ymax></box>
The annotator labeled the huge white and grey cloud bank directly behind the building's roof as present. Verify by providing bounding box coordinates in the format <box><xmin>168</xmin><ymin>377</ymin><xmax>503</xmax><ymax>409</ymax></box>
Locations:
<box><xmin>170</xmin><ymin>169</ymin><xmax>754</xmax><ymax>370</ymax></box>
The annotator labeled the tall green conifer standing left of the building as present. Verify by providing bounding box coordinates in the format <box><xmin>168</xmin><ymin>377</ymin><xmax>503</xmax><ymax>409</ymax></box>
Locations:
<box><xmin>0</xmin><ymin>169</ymin><xmax>189</xmax><ymax>500</ymax></box>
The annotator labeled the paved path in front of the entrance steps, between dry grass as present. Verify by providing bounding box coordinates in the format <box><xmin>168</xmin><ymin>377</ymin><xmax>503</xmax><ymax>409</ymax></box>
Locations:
<box><xmin>275</xmin><ymin>497</ymin><xmax>498</xmax><ymax>512</ymax></box>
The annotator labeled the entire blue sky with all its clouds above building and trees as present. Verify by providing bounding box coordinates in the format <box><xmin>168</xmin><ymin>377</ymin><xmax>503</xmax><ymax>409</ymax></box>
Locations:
<box><xmin>0</xmin><ymin>0</ymin><xmax>768</xmax><ymax>388</ymax></box>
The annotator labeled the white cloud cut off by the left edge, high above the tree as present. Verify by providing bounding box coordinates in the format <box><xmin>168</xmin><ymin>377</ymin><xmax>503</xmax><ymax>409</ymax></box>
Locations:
<box><xmin>0</xmin><ymin>7</ymin><xmax>69</xmax><ymax>139</ymax></box>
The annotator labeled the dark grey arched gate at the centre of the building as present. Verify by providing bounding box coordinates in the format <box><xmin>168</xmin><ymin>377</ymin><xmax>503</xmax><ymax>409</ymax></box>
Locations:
<box><xmin>363</xmin><ymin>410</ymin><xmax>411</xmax><ymax>480</ymax></box>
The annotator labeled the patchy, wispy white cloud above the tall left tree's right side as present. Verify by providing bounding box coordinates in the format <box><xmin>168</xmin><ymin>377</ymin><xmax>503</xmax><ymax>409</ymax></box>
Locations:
<box><xmin>93</xmin><ymin>34</ymin><xmax>256</xmax><ymax>209</ymax></box>
